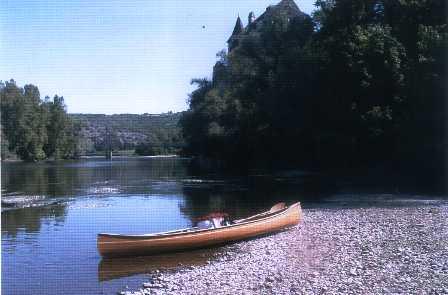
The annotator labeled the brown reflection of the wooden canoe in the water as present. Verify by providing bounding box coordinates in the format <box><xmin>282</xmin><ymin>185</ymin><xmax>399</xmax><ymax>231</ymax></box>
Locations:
<box><xmin>98</xmin><ymin>248</ymin><xmax>223</xmax><ymax>282</ymax></box>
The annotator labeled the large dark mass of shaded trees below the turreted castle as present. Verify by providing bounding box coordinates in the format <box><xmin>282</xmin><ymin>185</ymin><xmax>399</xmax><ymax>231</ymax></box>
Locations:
<box><xmin>181</xmin><ymin>0</ymin><xmax>448</xmax><ymax>173</ymax></box>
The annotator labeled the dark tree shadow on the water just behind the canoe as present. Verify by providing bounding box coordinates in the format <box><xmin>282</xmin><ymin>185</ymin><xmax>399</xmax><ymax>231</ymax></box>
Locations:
<box><xmin>180</xmin><ymin>175</ymin><xmax>337</xmax><ymax>220</ymax></box>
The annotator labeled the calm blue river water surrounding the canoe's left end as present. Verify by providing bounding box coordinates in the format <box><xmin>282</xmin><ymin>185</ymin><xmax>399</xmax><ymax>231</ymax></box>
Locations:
<box><xmin>1</xmin><ymin>158</ymin><xmax>316</xmax><ymax>294</ymax></box>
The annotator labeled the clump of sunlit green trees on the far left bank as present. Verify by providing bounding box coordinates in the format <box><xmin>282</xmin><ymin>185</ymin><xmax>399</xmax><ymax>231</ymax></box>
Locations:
<box><xmin>0</xmin><ymin>80</ymin><xmax>80</xmax><ymax>161</ymax></box>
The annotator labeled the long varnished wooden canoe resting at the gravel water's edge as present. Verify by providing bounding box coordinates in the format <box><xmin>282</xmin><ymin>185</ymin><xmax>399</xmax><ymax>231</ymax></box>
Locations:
<box><xmin>98</xmin><ymin>203</ymin><xmax>302</xmax><ymax>257</ymax></box>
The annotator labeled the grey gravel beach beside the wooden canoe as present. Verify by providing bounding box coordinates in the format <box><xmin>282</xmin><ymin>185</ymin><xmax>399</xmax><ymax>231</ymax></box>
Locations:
<box><xmin>119</xmin><ymin>197</ymin><xmax>448</xmax><ymax>294</ymax></box>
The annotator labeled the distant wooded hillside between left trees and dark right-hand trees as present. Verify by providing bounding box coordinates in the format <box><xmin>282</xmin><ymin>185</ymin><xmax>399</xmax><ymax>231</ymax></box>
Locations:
<box><xmin>70</xmin><ymin>112</ymin><xmax>183</xmax><ymax>154</ymax></box>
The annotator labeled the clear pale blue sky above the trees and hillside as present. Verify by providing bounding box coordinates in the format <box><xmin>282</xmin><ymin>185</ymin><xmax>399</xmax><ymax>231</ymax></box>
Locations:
<box><xmin>0</xmin><ymin>0</ymin><xmax>314</xmax><ymax>114</ymax></box>
